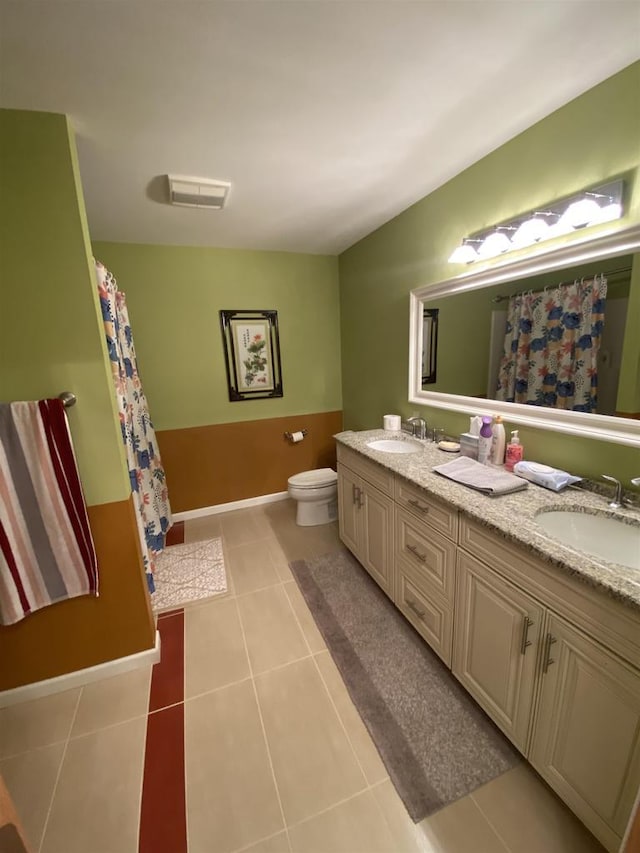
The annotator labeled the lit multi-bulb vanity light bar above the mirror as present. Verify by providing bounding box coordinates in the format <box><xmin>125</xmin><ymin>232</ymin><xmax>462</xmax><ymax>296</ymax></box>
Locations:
<box><xmin>449</xmin><ymin>180</ymin><xmax>624</xmax><ymax>264</ymax></box>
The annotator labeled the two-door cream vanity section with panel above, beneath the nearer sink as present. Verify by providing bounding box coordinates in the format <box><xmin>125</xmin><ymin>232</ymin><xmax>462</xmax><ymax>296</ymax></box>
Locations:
<box><xmin>453</xmin><ymin>519</ymin><xmax>640</xmax><ymax>850</ymax></box>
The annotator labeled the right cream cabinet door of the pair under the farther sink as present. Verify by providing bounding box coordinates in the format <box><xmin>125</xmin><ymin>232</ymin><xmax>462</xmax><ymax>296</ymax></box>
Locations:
<box><xmin>360</xmin><ymin>481</ymin><xmax>394</xmax><ymax>598</ymax></box>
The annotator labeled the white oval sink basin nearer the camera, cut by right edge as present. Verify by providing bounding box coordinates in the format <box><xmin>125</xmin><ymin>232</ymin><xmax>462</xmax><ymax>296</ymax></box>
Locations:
<box><xmin>536</xmin><ymin>510</ymin><xmax>640</xmax><ymax>569</ymax></box>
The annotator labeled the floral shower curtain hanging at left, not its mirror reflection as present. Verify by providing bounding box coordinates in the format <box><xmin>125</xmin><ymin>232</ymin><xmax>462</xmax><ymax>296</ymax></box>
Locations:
<box><xmin>96</xmin><ymin>261</ymin><xmax>172</xmax><ymax>592</ymax></box>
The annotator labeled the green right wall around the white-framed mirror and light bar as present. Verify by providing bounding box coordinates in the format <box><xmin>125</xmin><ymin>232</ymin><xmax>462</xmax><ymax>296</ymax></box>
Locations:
<box><xmin>339</xmin><ymin>63</ymin><xmax>640</xmax><ymax>480</ymax></box>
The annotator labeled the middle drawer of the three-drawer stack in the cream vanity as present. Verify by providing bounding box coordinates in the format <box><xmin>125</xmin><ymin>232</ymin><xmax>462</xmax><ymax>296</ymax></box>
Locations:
<box><xmin>396</xmin><ymin>506</ymin><xmax>456</xmax><ymax>604</ymax></box>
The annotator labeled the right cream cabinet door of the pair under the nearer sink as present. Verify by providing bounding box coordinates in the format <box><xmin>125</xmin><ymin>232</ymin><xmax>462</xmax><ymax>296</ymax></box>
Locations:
<box><xmin>529</xmin><ymin>614</ymin><xmax>640</xmax><ymax>851</ymax></box>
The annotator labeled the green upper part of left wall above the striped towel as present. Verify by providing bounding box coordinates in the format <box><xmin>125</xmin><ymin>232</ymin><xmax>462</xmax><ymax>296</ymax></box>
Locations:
<box><xmin>0</xmin><ymin>110</ymin><xmax>130</xmax><ymax>505</ymax></box>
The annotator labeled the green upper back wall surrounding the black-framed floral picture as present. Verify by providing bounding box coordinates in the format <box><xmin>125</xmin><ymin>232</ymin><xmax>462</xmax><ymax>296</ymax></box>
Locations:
<box><xmin>94</xmin><ymin>240</ymin><xmax>342</xmax><ymax>430</ymax></box>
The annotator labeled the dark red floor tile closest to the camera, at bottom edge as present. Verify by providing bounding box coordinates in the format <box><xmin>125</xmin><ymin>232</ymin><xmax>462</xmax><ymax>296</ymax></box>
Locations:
<box><xmin>138</xmin><ymin>703</ymin><xmax>187</xmax><ymax>853</ymax></box>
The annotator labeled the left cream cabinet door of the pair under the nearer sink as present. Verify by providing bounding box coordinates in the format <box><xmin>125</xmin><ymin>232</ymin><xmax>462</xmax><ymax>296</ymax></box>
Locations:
<box><xmin>453</xmin><ymin>551</ymin><xmax>544</xmax><ymax>754</ymax></box>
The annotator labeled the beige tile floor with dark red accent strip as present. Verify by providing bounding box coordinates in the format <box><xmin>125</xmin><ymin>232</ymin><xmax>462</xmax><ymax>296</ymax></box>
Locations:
<box><xmin>0</xmin><ymin>501</ymin><xmax>602</xmax><ymax>853</ymax></box>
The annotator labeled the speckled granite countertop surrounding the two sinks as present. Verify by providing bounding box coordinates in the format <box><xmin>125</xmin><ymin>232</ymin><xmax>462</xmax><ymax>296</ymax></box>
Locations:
<box><xmin>335</xmin><ymin>429</ymin><xmax>640</xmax><ymax>610</ymax></box>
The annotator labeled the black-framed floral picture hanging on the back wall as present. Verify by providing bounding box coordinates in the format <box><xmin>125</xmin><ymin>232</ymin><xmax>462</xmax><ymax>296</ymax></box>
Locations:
<box><xmin>220</xmin><ymin>311</ymin><xmax>283</xmax><ymax>403</ymax></box>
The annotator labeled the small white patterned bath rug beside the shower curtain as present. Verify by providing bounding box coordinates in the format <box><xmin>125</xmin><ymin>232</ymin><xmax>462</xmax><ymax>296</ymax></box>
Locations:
<box><xmin>151</xmin><ymin>538</ymin><xmax>227</xmax><ymax>613</ymax></box>
